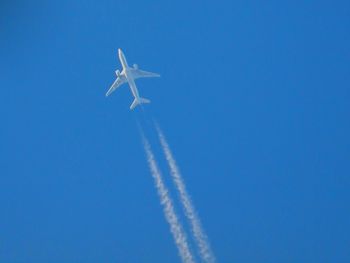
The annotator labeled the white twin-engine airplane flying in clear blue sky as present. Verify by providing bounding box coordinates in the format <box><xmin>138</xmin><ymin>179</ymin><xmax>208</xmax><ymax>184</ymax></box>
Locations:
<box><xmin>106</xmin><ymin>48</ymin><xmax>160</xmax><ymax>110</ymax></box>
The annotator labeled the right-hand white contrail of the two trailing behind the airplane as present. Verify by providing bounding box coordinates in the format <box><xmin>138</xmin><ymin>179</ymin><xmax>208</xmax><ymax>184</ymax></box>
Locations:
<box><xmin>155</xmin><ymin>122</ymin><xmax>216</xmax><ymax>263</ymax></box>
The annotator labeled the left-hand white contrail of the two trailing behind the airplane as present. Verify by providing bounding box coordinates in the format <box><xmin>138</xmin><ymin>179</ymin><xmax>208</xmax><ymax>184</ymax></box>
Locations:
<box><xmin>142</xmin><ymin>135</ymin><xmax>194</xmax><ymax>263</ymax></box>
